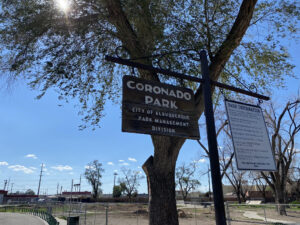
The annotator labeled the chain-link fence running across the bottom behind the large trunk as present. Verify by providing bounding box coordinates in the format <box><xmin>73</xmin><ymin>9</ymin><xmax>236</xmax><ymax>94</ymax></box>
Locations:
<box><xmin>1</xmin><ymin>202</ymin><xmax>300</xmax><ymax>225</ymax></box>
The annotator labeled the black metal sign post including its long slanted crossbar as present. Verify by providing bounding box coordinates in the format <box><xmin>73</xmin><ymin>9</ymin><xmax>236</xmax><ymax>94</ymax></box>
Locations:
<box><xmin>105</xmin><ymin>50</ymin><xmax>270</xmax><ymax>225</ymax></box>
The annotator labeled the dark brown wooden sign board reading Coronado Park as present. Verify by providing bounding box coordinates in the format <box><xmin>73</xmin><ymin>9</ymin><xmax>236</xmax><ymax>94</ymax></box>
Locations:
<box><xmin>122</xmin><ymin>76</ymin><xmax>199</xmax><ymax>139</ymax></box>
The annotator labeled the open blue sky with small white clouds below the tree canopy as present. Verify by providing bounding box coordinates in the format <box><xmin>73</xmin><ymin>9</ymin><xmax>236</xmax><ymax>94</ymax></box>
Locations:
<box><xmin>0</xmin><ymin>40</ymin><xmax>300</xmax><ymax>194</ymax></box>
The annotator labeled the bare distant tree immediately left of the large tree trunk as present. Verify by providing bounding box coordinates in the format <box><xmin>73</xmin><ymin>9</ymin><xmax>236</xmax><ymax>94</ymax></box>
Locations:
<box><xmin>119</xmin><ymin>167</ymin><xmax>144</xmax><ymax>199</ymax></box>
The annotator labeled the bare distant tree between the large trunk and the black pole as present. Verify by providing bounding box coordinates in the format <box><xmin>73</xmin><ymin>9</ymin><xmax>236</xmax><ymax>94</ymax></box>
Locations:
<box><xmin>176</xmin><ymin>162</ymin><xmax>200</xmax><ymax>201</ymax></box>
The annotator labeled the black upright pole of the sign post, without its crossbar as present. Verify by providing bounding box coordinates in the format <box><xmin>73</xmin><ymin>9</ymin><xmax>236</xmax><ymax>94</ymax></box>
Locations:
<box><xmin>200</xmin><ymin>50</ymin><xmax>226</xmax><ymax>225</ymax></box>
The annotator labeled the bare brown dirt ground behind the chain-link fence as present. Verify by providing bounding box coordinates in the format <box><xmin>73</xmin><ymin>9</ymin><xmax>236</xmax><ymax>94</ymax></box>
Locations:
<box><xmin>53</xmin><ymin>203</ymin><xmax>300</xmax><ymax>225</ymax></box>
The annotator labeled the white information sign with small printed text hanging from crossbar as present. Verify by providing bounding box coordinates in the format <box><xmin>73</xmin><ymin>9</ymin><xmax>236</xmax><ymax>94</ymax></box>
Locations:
<box><xmin>225</xmin><ymin>100</ymin><xmax>276</xmax><ymax>171</ymax></box>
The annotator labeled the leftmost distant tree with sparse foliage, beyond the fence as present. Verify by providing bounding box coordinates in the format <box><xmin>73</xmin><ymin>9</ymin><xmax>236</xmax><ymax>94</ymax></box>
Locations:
<box><xmin>84</xmin><ymin>160</ymin><xmax>104</xmax><ymax>199</ymax></box>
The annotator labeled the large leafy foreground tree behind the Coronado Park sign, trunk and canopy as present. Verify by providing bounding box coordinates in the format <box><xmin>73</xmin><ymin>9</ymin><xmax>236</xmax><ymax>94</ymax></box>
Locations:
<box><xmin>0</xmin><ymin>0</ymin><xmax>299</xmax><ymax>225</ymax></box>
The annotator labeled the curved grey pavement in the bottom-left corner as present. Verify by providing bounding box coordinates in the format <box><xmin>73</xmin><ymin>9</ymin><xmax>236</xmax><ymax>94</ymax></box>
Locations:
<box><xmin>0</xmin><ymin>213</ymin><xmax>48</xmax><ymax>225</ymax></box>
